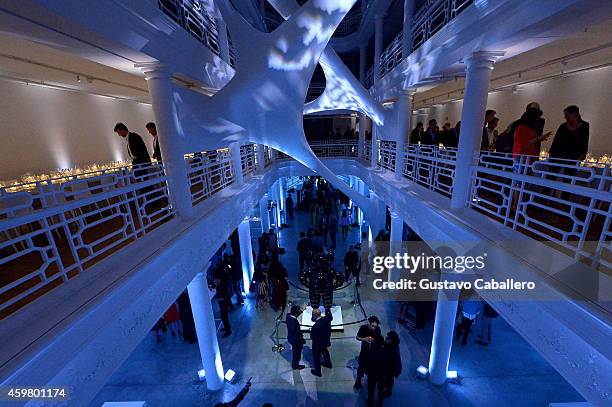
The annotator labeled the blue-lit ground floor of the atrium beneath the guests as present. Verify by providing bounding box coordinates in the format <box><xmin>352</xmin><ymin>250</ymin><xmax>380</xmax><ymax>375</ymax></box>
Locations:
<box><xmin>91</xmin><ymin>207</ymin><xmax>582</xmax><ymax>407</ymax></box>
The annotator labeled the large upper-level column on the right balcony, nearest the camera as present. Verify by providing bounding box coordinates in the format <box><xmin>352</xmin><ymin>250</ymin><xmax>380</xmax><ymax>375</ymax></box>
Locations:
<box><xmin>451</xmin><ymin>51</ymin><xmax>503</xmax><ymax>209</ymax></box>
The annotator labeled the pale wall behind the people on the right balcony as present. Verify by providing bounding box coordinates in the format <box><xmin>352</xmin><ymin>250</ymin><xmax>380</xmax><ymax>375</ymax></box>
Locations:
<box><xmin>412</xmin><ymin>67</ymin><xmax>612</xmax><ymax>156</ymax></box>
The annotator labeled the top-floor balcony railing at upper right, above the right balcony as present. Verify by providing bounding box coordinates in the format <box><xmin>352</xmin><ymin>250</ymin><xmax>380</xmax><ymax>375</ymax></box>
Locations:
<box><xmin>364</xmin><ymin>0</ymin><xmax>474</xmax><ymax>88</ymax></box>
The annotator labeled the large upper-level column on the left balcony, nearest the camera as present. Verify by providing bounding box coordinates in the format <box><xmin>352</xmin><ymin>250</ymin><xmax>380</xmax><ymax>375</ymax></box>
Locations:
<box><xmin>138</xmin><ymin>64</ymin><xmax>194</xmax><ymax>219</ymax></box>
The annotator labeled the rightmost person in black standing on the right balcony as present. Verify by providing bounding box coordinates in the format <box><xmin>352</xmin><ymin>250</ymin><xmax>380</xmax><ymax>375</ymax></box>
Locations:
<box><xmin>549</xmin><ymin>105</ymin><xmax>589</xmax><ymax>161</ymax></box>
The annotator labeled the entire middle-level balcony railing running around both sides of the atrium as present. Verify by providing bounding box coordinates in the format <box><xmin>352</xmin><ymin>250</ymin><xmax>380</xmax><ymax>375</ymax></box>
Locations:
<box><xmin>0</xmin><ymin>140</ymin><xmax>612</xmax><ymax>319</ymax></box>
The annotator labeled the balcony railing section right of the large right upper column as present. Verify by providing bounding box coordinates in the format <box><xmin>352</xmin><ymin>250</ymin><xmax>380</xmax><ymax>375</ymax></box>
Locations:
<box><xmin>471</xmin><ymin>152</ymin><xmax>612</xmax><ymax>269</ymax></box>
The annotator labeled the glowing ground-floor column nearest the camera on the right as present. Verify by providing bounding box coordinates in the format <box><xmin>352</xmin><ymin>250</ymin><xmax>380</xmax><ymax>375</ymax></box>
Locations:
<box><xmin>429</xmin><ymin>274</ymin><xmax>459</xmax><ymax>384</ymax></box>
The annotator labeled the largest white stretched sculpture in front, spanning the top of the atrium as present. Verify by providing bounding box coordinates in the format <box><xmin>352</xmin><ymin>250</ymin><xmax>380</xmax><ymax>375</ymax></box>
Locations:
<box><xmin>167</xmin><ymin>0</ymin><xmax>380</xmax><ymax>228</ymax></box>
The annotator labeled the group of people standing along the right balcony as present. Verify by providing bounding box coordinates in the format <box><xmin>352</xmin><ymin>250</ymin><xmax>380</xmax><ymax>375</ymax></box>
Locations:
<box><xmin>409</xmin><ymin>102</ymin><xmax>589</xmax><ymax>160</ymax></box>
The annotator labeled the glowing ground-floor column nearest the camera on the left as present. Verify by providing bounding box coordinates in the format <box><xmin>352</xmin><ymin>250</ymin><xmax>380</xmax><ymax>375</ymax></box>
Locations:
<box><xmin>187</xmin><ymin>273</ymin><xmax>225</xmax><ymax>390</ymax></box>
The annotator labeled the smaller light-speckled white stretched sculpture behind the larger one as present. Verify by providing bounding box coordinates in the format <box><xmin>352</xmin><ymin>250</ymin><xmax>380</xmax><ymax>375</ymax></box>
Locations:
<box><xmin>268</xmin><ymin>0</ymin><xmax>384</xmax><ymax>125</ymax></box>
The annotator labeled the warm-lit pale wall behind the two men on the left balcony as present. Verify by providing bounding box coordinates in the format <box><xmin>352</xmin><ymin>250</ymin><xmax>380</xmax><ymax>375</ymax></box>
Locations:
<box><xmin>0</xmin><ymin>80</ymin><xmax>154</xmax><ymax>180</ymax></box>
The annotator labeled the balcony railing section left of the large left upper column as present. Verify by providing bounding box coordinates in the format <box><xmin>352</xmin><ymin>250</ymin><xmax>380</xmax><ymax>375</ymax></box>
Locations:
<box><xmin>0</xmin><ymin>162</ymin><xmax>174</xmax><ymax>319</ymax></box>
